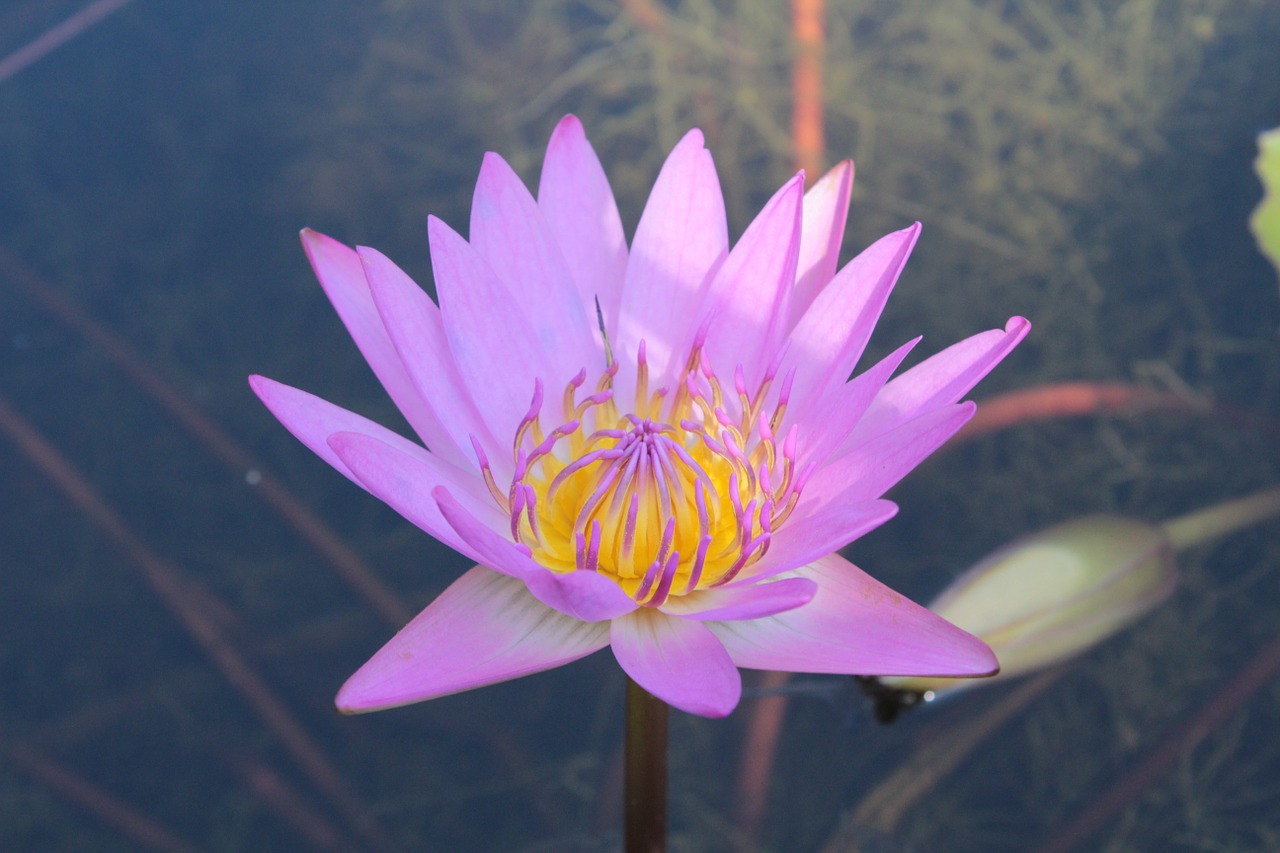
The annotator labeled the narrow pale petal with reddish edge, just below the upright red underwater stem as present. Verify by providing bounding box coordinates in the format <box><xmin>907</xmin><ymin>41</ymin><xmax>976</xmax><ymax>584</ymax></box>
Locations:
<box><xmin>791</xmin><ymin>160</ymin><xmax>854</xmax><ymax>319</ymax></box>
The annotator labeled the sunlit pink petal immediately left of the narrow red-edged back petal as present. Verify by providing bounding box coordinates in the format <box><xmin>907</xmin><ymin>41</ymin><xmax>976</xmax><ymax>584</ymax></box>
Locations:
<box><xmin>701</xmin><ymin>173</ymin><xmax>804</xmax><ymax>383</ymax></box>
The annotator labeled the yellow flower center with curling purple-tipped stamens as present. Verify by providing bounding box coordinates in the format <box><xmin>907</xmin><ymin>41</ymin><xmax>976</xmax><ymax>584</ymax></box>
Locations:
<box><xmin>477</xmin><ymin>342</ymin><xmax>812</xmax><ymax>607</ymax></box>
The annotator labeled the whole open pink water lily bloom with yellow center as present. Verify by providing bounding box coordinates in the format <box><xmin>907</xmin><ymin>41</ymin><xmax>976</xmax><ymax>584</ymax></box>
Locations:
<box><xmin>251</xmin><ymin>111</ymin><xmax>1028</xmax><ymax>716</ymax></box>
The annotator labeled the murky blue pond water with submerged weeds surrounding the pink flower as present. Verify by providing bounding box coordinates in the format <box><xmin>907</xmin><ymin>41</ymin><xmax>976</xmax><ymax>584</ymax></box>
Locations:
<box><xmin>0</xmin><ymin>0</ymin><xmax>1280</xmax><ymax>850</ymax></box>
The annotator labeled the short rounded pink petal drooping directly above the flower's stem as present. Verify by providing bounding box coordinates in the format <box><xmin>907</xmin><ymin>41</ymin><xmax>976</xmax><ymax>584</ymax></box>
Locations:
<box><xmin>609</xmin><ymin>607</ymin><xmax>742</xmax><ymax>717</ymax></box>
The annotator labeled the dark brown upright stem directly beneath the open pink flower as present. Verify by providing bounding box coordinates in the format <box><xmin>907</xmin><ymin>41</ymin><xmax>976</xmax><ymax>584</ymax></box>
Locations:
<box><xmin>623</xmin><ymin>679</ymin><xmax>667</xmax><ymax>853</ymax></box>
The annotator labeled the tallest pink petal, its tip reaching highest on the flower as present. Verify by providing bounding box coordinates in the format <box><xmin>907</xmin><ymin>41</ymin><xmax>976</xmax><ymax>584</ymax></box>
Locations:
<box><xmin>538</xmin><ymin>115</ymin><xmax>627</xmax><ymax>329</ymax></box>
